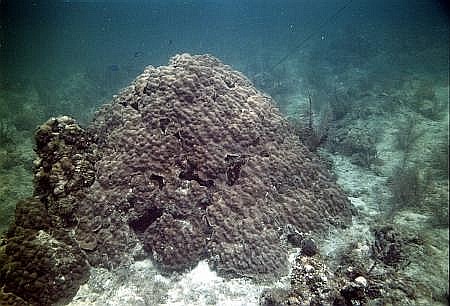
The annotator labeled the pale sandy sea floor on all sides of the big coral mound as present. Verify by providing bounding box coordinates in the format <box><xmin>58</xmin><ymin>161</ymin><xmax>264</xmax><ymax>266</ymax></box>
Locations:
<box><xmin>0</xmin><ymin>63</ymin><xmax>449</xmax><ymax>306</ymax></box>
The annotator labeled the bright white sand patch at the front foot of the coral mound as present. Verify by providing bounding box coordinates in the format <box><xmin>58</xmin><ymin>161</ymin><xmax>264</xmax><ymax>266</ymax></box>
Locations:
<box><xmin>69</xmin><ymin>255</ymin><xmax>286</xmax><ymax>306</ymax></box>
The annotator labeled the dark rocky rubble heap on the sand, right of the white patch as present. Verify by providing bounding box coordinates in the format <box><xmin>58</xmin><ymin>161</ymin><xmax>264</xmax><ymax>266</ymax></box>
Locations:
<box><xmin>260</xmin><ymin>226</ymin><xmax>428</xmax><ymax>306</ymax></box>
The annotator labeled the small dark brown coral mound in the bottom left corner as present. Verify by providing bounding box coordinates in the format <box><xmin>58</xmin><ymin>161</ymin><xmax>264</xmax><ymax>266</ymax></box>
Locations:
<box><xmin>0</xmin><ymin>198</ymin><xmax>89</xmax><ymax>305</ymax></box>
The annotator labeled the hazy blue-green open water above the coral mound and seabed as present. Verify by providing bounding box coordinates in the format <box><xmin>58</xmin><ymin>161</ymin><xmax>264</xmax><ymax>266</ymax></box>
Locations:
<box><xmin>0</xmin><ymin>0</ymin><xmax>449</xmax><ymax>121</ymax></box>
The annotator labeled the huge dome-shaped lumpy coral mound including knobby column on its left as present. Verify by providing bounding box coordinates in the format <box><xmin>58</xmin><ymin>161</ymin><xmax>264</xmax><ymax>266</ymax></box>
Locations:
<box><xmin>0</xmin><ymin>54</ymin><xmax>351</xmax><ymax>304</ymax></box>
